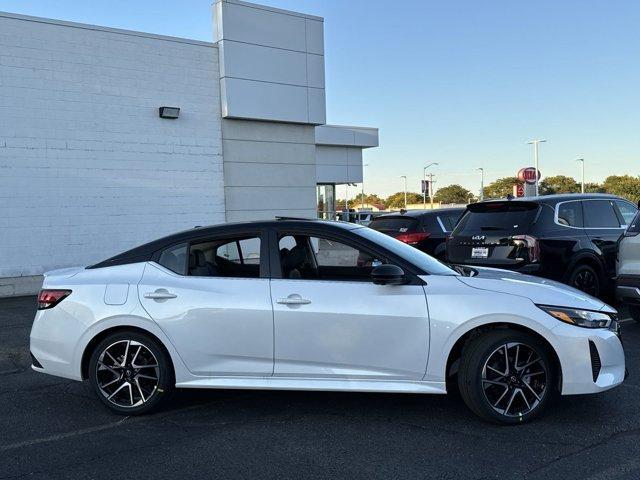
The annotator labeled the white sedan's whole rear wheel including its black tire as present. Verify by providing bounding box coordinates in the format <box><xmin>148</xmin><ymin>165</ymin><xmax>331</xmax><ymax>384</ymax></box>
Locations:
<box><xmin>89</xmin><ymin>330</ymin><xmax>175</xmax><ymax>415</ymax></box>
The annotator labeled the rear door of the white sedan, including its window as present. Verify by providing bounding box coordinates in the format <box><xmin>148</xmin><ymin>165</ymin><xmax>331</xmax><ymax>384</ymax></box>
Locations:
<box><xmin>138</xmin><ymin>232</ymin><xmax>273</xmax><ymax>376</ymax></box>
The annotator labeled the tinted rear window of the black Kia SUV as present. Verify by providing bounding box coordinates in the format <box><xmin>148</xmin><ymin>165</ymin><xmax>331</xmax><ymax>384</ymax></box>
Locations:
<box><xmin>453</xmin><ymin>202</ymin><xmax>539</xmax><ymax>235</ymax></box>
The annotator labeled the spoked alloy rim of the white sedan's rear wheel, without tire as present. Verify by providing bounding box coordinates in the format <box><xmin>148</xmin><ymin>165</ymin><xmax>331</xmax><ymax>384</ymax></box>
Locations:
<box><xmin>95</xmin><ymin>340</ymin><xmax>160</xmax><ymax>408</ymax></box>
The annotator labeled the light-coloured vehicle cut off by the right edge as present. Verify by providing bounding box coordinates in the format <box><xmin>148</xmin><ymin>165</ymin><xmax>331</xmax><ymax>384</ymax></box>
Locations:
<box><xmin>616</xmin><ymin>206</ymin><xmax>640</xmax><ymax>322</ymax></box>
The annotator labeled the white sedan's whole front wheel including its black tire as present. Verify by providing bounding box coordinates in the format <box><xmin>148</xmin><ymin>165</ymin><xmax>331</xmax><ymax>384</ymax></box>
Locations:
<box><xmin>458</xmin><ymin>329</ymin><xmax>556</xmax><ymax>424</ymax></box>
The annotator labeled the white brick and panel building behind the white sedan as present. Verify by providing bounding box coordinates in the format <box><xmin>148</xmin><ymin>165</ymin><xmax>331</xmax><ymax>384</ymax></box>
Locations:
<box><xmin>0</xmin><ymin>0</ymin><xmax>378</xmax><ymax>296</ymax></box>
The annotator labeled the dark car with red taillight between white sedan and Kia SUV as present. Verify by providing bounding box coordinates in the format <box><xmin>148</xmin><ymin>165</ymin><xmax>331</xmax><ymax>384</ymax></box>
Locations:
<box><xmin>369</xmin><ymin>208</ymin><xmax>465</xmax><ymax>259</ymax></box>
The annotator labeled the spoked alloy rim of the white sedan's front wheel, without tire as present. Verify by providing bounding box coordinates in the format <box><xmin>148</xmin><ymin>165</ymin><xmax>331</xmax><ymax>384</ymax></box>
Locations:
<box><xmin>482</xmin><ymin>342</ymin><xmax>548</xmax><ymax>417</ymax></box>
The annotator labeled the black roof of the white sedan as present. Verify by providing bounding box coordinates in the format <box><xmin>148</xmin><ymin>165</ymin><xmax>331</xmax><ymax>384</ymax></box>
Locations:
<box><xmin>87</xmin><ymin>217</ymin><xmax>362</xmax><ymax>268</ymax></box>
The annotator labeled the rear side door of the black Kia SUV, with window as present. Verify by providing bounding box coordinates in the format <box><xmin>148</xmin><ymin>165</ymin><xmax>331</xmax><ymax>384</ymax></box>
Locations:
<box><xmin>582</xmin><ymin>199</ymin><xmax>625</xmax><ymax>278</ymax></box>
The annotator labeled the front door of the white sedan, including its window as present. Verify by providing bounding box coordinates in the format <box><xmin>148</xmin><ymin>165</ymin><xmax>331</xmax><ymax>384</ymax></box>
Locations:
<box><xmin>271</xmin><ymin>230</ymin><xmax>429</xmax><ymax>380</ymax></box>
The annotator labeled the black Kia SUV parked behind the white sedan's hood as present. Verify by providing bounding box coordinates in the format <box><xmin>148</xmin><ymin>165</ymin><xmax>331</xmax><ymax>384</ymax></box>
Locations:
<box><xmin>447</xmin><ymin>194</ymin><xmax>637</xmax><ymax>296</ymax></box>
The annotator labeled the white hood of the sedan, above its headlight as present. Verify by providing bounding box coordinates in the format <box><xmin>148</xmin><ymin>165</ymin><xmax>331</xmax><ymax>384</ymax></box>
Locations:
<box><xmin>458</xmin><ymin>267</ymin><xmax>615</xmax><ymax>312</ymax></box>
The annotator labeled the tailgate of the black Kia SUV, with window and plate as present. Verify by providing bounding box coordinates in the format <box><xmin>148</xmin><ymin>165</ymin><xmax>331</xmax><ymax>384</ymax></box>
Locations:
<box><xmin>447</xmin><ymin>201</ymin><xmax>539</xmax><ymax>268</ymax></box>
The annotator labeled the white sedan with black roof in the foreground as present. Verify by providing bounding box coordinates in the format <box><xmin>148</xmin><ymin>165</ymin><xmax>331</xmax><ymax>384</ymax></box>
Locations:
<box><xmin>31</xmin><ymin>219</ymin><xmax>625</xmax><ymax>423</ymax></box>
